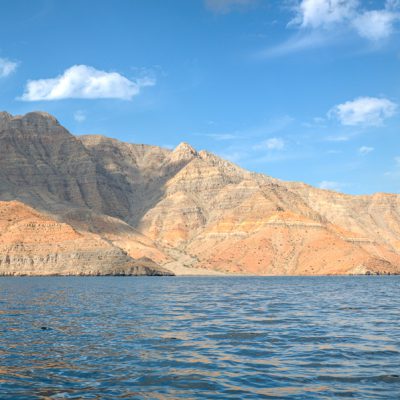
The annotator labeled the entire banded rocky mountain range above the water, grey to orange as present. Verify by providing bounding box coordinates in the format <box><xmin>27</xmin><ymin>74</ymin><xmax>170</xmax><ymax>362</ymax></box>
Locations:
<box><xmin>0</xmin><ymin>112</ymin><xmax>400</xmax><ymax>275</ymax></box>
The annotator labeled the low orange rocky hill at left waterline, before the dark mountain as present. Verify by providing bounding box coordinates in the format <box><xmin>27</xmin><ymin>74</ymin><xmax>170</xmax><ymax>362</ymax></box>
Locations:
<box><xmin>0</xmin><ymin>201</ymin><xmax>170</xmax><ymax>275</ymax></box>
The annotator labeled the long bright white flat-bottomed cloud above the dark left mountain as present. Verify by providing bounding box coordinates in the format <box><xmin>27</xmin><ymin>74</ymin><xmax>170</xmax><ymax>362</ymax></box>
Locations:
<box><xmin>21</xmin><ymin>65</ymin><xmax>155</xmax><ymax>101</ymax></box>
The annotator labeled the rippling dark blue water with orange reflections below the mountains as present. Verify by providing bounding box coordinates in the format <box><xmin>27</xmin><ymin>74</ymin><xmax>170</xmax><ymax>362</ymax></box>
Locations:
<box><xmin>0</xmin><ymin>276</ymin><xmax>400</xmax><ymax>400</ymax></box>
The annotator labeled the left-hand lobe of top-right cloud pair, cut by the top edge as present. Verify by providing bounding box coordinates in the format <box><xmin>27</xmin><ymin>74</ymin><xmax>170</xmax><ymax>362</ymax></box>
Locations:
<box><xmin>292</xmin><ymin>0</ymin><xmax>358</xmax><ymax>28</ymax></box>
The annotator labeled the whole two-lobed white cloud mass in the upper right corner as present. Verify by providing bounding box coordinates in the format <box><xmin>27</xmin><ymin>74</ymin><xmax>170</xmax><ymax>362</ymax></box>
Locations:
<box><xmin>290</xmin><ymin>0</ymin><xmax>400</xmax><ymax>41</ymax></box>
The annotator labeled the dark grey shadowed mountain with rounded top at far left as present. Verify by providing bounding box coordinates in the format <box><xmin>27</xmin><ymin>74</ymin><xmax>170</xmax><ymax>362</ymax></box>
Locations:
<box><xmin>0</xmin><ymin>112</ymin><xmax>129</xmax><ymax>216</ymax></box>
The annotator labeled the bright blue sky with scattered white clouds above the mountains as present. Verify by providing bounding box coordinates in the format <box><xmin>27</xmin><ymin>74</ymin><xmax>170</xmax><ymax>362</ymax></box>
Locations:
<box><xmin>0</xmin><ymin>0</ymin><xmax>400</xmax><ymax>194</ymax></box>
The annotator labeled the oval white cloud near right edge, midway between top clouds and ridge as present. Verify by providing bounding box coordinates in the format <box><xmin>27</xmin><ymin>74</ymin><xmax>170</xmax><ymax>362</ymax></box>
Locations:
<box><xmin>328</xmin><ymin>97</ymin><xmax>397</xmax><ymax>126</ymax></box>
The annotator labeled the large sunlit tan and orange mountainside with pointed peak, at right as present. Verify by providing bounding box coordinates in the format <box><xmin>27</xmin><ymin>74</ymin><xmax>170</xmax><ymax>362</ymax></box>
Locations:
<box><xmin>83</xmin><ymin>138</ymin><xmax>400</xmax><ymax>274</ymax></box>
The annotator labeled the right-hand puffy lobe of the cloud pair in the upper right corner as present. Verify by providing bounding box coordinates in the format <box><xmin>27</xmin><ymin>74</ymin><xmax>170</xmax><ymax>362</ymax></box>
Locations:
<box><xmin>353</xmin><ymin>10</ymin><xmax>399</xmax><ymax>41</ymax></box>
